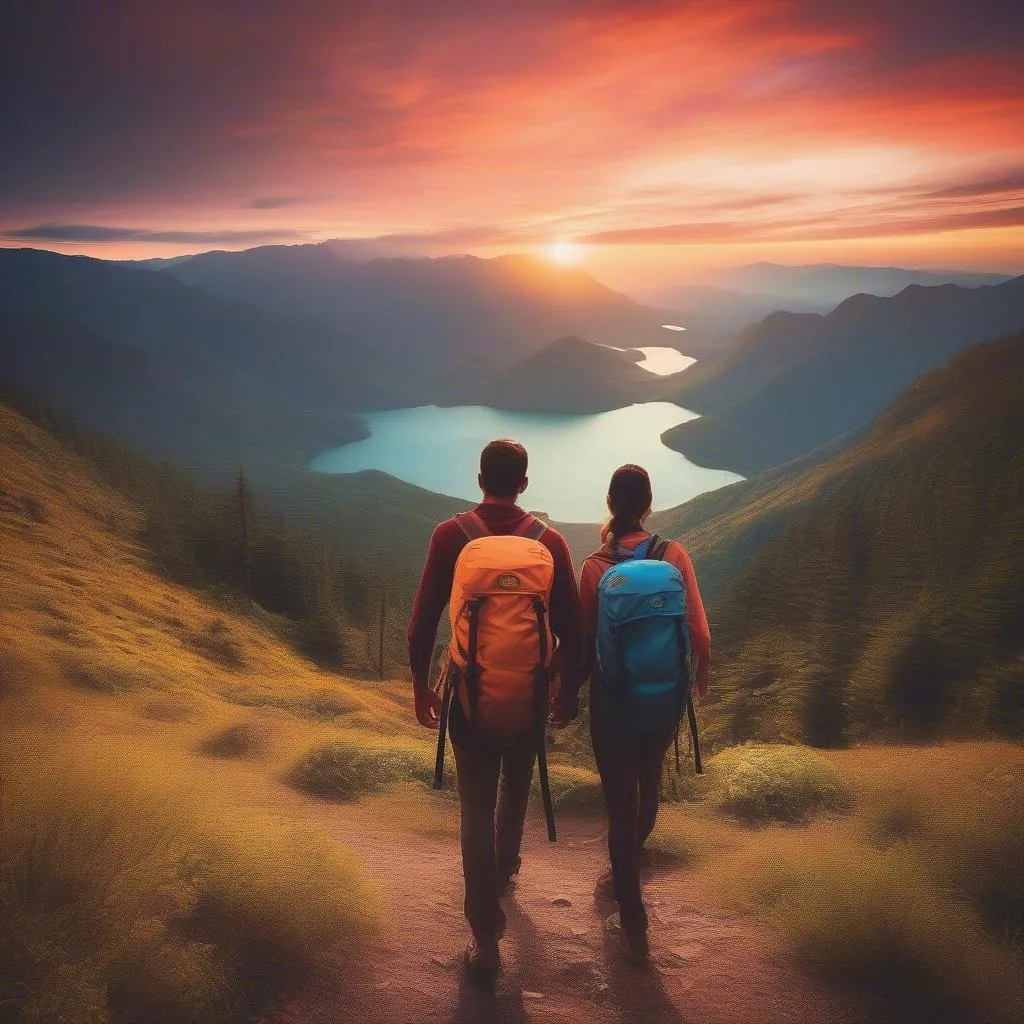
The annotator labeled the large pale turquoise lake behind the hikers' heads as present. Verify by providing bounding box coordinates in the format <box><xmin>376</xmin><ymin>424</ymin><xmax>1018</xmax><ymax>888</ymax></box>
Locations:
<box><xmin>310</xmin><ymin>401</ymin><xmax>742</xmax><ymax>522</ymax></box>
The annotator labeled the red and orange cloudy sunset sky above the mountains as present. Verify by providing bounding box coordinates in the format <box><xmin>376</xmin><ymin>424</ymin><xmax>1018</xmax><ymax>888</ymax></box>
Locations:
<box><xmin>0</xmin><ymin>0</ymin><xmax>1024</xmax><ymax>289</ymax></box>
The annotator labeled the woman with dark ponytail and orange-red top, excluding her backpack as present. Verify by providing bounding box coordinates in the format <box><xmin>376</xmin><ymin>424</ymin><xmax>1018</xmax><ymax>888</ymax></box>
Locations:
<box><xmin>580</xmin><ymin>465</ymin><xmax>711</xmax><ymax>962</ymax></box>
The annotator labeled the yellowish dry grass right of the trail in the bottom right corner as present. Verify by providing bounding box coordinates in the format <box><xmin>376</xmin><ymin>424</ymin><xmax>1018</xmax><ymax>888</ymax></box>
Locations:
<box><xmin>717</xmin><ymin>828</ymin><xmax>1024</xmax><ymax>1024</ymax></box>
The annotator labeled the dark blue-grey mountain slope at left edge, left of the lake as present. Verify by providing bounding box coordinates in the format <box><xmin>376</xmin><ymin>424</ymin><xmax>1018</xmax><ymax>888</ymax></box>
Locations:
<box><xmin>0</xmin><ymin>250</ymin><xmax>395</xmax><ymax>464</ymax></box>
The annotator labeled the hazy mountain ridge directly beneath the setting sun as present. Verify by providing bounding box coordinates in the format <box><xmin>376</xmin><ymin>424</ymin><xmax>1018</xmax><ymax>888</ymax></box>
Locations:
<box><xmin>155</xmin><ymin>242</ymin><xmax>671</xmax><ymax>377</ymax></box>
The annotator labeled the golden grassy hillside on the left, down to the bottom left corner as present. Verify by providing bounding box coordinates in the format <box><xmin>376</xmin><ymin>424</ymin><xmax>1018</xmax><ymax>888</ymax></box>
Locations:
<box><xmin>0</xmin><ymin>410</ymin><xmax>419</xmax><ymax>1022</ymax></box>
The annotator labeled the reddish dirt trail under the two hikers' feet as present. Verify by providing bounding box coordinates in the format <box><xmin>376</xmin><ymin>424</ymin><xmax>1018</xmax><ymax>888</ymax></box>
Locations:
<box><xmin>267</xmin><ymin>802</ymin><xmax>851</xmax><ymax>1024</ymax></box>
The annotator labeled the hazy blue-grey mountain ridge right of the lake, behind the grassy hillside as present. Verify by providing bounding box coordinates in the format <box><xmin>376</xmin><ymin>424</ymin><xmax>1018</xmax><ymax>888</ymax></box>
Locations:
<box><xmin>663</xmin><ymin>278</ymin><xmax>1024</xmax><ymax>476</ymax></box>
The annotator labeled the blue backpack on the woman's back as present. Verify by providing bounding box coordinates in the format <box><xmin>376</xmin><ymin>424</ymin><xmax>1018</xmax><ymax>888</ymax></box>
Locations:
<box><xmin>593</xmin><ymin>536</ymin><xmax>700</xmax><ymax>772</ymax></box>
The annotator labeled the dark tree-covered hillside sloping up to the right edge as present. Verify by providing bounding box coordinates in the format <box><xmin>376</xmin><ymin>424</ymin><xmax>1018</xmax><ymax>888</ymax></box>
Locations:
<box><xmin>692</xmin><ymin>334</ymin><xmax>1024</xmax><ymax>744</ymax></box>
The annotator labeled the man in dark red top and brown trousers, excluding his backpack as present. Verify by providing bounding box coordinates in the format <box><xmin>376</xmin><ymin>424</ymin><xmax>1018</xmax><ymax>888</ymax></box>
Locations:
<box><xmin>408</xmin><ymin>439</ymin><xmax>582</xmax><ymax>972</ymax></box>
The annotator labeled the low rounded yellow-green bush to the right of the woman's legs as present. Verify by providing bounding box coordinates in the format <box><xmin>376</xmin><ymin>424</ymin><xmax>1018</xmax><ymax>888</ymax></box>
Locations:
<box><xmin>709</xmin><ymin>743</ymin><xmax>853</xmax><ymax>821</ymax></box>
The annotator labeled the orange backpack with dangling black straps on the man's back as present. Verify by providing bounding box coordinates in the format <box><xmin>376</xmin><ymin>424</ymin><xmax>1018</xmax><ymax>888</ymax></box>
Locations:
<box><xmin>435</xmin><ymin>512</ymin><xmax>555</xmax><ymax>840</ymax></box>
